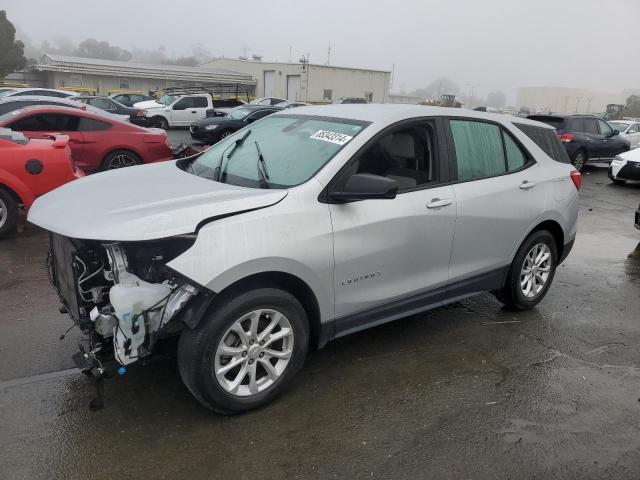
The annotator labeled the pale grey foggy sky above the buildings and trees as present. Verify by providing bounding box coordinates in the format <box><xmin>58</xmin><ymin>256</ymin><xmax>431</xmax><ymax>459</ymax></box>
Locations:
<box><xmin>0</xmin><ymin>0</ymin><xmax>640</xmax><ymax>102</ymax></box>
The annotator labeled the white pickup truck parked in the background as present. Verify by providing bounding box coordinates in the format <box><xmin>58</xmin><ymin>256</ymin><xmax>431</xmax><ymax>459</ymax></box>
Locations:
<box><xmin>134</xmin><ymin>93</ymin><xmax>213</xmax><ymax>130</ymax></box>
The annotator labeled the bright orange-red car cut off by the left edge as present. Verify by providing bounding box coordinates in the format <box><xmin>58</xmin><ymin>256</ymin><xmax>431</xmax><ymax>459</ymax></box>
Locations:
<box><xmin>0</xmin><ymin>128</ymin><xmax>84</xmax><ymax>238</ymax></box>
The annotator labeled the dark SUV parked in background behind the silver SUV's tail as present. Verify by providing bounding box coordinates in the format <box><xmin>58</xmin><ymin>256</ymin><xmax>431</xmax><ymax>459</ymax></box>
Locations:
<box><xmin>527</xmin><ymin>114</ymin><xmax>630</xmax><ymax>171</ymax></box>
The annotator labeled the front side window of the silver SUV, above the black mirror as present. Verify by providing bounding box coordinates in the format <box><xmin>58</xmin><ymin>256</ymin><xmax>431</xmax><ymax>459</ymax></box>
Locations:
<box><xmin>338</xmin><ymin>121</ymin><xmax>437</xmax><ymax>192</ymax></box>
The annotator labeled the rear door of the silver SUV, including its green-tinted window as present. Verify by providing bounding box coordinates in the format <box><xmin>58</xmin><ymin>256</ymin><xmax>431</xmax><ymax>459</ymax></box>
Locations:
<box><xmin>447</xmin><ymin>118</ymin><xmax>546</xmax><ymax>299</ymax></box>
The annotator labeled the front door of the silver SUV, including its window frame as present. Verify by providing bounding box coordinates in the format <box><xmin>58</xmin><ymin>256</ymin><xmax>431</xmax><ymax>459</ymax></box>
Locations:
<box><xmin>329</xmin><ymin>120</ymin><xmax>456</xmax><ymax>322</ymax></box>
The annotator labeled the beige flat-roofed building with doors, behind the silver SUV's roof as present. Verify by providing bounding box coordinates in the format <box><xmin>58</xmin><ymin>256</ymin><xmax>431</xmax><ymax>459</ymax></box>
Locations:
<box><xmin>199</xmin><ymin>56</ymin><xmax>391</xmax><ymax>103</ymax></box>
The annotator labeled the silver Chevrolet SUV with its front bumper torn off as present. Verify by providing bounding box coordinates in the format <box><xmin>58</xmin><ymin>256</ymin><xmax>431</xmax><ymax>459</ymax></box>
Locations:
<box><xmin>29</xmin><ymin>105</ymin><xmax>580</xmax><ymax>413</ymax></box>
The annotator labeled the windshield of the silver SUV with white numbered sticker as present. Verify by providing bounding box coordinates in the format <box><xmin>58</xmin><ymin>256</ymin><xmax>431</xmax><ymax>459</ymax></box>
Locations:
<box><xmin>188</xmin><ymin>115</ymin><xmax>368</xmax><ymax>188</ymax></box>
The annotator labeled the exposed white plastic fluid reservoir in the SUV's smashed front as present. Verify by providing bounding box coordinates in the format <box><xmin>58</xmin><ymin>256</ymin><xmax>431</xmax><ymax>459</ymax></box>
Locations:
<box><xmin>109</xmin><ymin>272</ymin><xmax>171</xmax><ymax>365</ymax></box>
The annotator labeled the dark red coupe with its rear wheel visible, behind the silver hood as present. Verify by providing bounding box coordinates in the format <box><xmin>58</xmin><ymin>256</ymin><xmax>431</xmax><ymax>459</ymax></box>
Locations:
<box><xmin>0</xmin><ymin>105</ymin><xmax>172</xmax><ymax>171</ymax></box>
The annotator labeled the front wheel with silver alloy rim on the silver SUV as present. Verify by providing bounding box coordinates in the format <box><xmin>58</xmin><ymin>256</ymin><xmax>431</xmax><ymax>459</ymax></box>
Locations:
<box><xmin>178</xmin><ymin>288</ymin><xmax>309</xmax><ymax>415</ymax></box>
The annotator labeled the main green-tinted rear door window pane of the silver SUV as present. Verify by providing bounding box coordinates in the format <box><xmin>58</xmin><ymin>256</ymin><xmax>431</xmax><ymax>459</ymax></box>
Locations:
<box><xmin>449</xmin><ymin>120</ymin><xmax>506</xmax><ymax>182</ymax></box>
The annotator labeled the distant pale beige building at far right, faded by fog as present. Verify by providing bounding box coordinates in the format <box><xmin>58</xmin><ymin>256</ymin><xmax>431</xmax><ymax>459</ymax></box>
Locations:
<box><xmin>516</xmin><ymin>87</ymin><xmax>626</xmax><ymax>113</ymax></box>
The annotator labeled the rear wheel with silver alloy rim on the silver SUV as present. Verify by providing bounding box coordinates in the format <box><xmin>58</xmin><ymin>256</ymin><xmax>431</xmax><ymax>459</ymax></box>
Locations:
<box><xmin>496</xmin><ymin>230</ymin><xmax>558</xmax><ymax>310</ymax></box>
